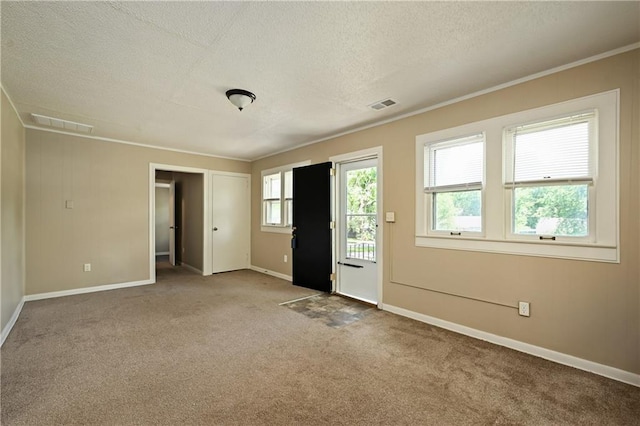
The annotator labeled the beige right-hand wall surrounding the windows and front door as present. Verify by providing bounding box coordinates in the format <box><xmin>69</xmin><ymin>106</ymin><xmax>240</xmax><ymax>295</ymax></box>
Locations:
<box><xmin>251</xmin><ymin>50</ymin><xmax>640</xmax><ymax>373</ymax></box>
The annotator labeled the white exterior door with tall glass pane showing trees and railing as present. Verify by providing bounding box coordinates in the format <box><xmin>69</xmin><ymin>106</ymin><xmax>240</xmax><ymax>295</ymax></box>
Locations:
<box><xmin>338</xmin><ymin>158</ymin><xmax>378</xmax><ymax>303</ymax></box>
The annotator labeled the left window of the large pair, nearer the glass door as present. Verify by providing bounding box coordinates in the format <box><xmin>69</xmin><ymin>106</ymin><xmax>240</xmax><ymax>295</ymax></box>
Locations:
<box><xmin>424</xmin><ymin>133</ymin><xmax>484</xmax><ymax>235</ymax></box>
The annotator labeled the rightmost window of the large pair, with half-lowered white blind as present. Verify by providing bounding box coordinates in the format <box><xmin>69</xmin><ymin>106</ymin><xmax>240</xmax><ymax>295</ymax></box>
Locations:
<box><xmin>504</xmin><ymin>110</ymin><xmax>597</xmax><ymax>241</ymax></box>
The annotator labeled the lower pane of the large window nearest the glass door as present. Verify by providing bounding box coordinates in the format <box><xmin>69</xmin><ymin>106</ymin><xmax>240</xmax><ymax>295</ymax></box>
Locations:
<box><xmin>433</xmin><ymin>190</ymin><xmax>482</xmax><ymax>232</ymax></box>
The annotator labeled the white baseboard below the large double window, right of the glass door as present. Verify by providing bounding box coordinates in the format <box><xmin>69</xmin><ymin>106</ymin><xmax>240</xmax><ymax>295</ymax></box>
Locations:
<box><xmin>382</xmin><ymin>305</ymin><xmax>640</xmax><ymax>387</ymax></box>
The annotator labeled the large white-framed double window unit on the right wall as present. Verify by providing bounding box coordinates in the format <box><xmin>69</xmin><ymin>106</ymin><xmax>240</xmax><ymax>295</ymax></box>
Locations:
<box><xmin>416</xmin><ymin>90</ymin><xmax>619</xmax><ymax>262</ymax></box>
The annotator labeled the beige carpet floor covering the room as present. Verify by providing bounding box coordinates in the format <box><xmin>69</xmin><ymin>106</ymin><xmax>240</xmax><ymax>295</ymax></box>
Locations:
<box><xmin>0</xmin><ymin>267</ymin><xmax>640</xmax><ymax>426</ymax></box>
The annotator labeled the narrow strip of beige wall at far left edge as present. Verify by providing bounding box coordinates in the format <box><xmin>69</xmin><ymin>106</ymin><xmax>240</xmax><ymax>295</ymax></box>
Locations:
<box><xmin>0</xmin><ymin>87</ymin><xmax>25</xmax><ymax>330</ymax></box>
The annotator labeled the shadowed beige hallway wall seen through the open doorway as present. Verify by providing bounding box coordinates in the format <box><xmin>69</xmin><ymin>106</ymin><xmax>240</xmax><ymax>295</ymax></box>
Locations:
<box><xmin>173</xmin><ymin>173</ymin><xmax>204</xmax><ymax>271</ymax></box>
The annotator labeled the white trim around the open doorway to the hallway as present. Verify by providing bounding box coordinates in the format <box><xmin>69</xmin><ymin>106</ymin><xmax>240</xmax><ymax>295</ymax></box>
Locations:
<box><xmin>149</xmin><ymin>163</ymin><xmax>212</xmax><ymax>283</ymax></box>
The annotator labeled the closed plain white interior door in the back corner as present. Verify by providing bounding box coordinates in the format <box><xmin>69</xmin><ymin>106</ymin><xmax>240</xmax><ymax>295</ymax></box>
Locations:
<box><xmin>211</xmin><ymin>173</ymin><xmax>251</xmax><ymax>273</ymax></box>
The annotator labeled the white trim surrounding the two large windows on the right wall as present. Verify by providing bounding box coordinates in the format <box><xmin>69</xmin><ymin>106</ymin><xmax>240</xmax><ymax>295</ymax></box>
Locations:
<box><xmin>415</xmin><ymin>89</ymin><xmax>620</xmax><ymax>263</ymax></box>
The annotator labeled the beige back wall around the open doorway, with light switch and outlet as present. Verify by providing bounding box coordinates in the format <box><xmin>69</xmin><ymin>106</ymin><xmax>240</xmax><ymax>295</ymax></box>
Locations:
<box><xmin>26</xmin><ymin>129</ymin><xmax>250</xmax><ymax>294</ymax></box>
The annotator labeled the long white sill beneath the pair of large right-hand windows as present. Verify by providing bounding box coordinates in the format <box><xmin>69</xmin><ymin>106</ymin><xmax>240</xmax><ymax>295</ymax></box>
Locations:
<box><xmin>415</xmin><ymin>235</ymin><xmax>620</xmax><ymax>263</ymax></box>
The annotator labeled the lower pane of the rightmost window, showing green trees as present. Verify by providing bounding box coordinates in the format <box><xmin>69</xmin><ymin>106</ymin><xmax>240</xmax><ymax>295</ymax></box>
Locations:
<box><xmin>513</xmin><ymin>185</ymin><xmax>589</xmax><ymax>237</ymax></box>
